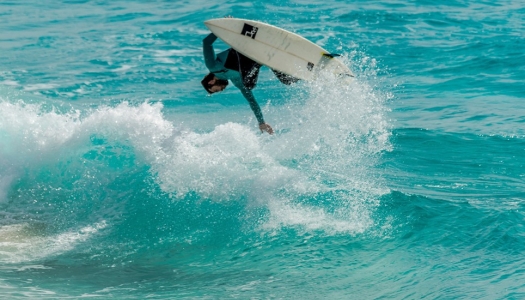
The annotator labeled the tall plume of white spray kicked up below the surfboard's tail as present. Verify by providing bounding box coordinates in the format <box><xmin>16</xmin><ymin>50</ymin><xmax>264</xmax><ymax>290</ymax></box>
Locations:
<box><xmin>258</xmin><ymin>61</ymin><xmax>391</xmax><ymax>234</ymax></box>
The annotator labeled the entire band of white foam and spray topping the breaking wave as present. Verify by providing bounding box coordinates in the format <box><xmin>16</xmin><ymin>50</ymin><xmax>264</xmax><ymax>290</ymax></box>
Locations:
<box><xmin>0</xmin><ymin>65</ymin><xmax>390</xmax><ymax>234</ymax></box>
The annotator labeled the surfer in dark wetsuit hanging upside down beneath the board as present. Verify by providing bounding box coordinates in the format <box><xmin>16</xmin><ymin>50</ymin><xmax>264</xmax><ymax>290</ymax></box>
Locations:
<box><xmin>201</xmin><ymin>33</ymin><xmax>273</xmax><ymax>134</ymax></box>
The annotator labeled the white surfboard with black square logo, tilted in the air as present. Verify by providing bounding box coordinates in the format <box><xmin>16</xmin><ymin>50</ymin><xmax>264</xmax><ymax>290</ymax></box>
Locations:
<box><xmin>204</xmin><ymin>18</ymin><xmax>354</xmax><ymax>80</ymax></box>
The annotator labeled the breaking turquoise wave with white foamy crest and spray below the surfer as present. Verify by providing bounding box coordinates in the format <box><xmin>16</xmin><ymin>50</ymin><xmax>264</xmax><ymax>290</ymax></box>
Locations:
<box><xmin>0</xmin><ymin>63</ymin><xmax>390</xmax><ymax>260</ymax></box>
